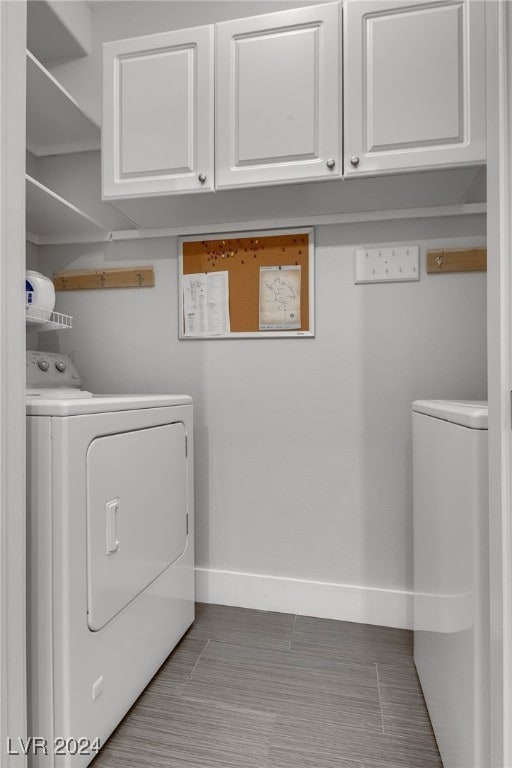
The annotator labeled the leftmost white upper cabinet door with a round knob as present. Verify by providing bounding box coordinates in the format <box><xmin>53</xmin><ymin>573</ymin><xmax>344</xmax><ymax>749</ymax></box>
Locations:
<box><xmin>102</xmin><ymin>25</ymin><xmax>214</xmax><ymax>199</ymax></box>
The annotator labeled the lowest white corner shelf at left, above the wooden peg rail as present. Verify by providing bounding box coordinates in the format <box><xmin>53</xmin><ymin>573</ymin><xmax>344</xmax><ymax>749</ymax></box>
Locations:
<box><xmin>25</xmin><ymin>175</ymin><xmax>107</xmax><ymax>245</ymax></box>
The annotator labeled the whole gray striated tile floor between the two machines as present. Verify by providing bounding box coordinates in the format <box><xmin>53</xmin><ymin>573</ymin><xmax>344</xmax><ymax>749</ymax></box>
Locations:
<box><xmin>92</xmin><ymin>605</ymin><xmax>442</xmax><ymax>768</ymax></box>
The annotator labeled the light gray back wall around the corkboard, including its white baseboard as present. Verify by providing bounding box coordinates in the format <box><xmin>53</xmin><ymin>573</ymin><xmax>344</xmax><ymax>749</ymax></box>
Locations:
<box><xmin>39</xmin><ymin>217</ymin><xmax>486</xmax><ymax>625</ymax></box>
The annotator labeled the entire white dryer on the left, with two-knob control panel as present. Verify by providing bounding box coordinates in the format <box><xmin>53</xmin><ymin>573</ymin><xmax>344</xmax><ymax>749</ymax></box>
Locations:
<box><xmin>27</xmin><ymin>352</ymin><xmax>194</xmax><ymax>767</ymax></box>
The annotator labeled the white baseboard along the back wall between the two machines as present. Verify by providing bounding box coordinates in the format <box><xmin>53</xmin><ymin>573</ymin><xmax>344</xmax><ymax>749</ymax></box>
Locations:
<box><xmin>196</xmin><ymin>568</ymin><xmax>413</xmax><ymax>629</ymax></box>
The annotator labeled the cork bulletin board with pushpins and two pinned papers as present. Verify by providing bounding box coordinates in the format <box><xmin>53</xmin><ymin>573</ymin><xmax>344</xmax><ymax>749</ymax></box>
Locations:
<box><xmin>179</xmin><ymin>228</ymin><xmax>314</xmax><ymax>339</ymax></box>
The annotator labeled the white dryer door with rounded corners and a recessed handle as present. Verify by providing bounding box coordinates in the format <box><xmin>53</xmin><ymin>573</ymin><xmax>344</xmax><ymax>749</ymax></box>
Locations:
<box><xmin>87</xmin><ymin>422</ymin><xmax>187</xmax><ymax>631</ymax></box>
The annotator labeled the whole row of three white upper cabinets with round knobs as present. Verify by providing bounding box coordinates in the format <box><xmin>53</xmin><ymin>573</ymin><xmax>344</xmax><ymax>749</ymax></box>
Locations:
<box><xmin>102</xmin><ymin>0</ymin><xmax>486</xmax><ymax>199</ymax></box>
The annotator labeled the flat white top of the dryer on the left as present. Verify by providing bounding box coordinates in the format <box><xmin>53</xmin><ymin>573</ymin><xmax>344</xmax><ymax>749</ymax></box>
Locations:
<box><xmin>26</xmin><ymin>395</ymin><xmax>192</xmax><ymax>416</ymax></box>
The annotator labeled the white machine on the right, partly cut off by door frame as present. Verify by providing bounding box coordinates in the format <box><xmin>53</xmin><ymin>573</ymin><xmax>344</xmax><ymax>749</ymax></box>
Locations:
<box><xmin>412</xmin><ymin>400</ymin><xmax>490</xmax><ymax>768</ymax></box>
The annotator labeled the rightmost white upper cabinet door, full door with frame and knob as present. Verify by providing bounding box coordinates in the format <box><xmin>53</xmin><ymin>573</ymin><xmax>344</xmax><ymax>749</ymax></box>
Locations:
<box><xmin>344</xmin><ymin>0</ymin><xmax>486</xmax><ymax>176</ymax></box>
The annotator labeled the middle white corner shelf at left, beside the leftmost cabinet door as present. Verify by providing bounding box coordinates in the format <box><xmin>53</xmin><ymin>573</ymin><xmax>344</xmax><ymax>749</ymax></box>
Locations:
<box><xmin>27</xmin><ymin>51</ymin><xmax>101</xmax><ymax>157</ymax></box>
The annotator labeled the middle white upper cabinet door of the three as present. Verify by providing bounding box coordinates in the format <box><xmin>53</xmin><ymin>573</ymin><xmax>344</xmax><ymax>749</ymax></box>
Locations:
<box><xmin>215</xmin><ymin>3</ymin><xmax>342</xmax><ymax>189</ymax></box>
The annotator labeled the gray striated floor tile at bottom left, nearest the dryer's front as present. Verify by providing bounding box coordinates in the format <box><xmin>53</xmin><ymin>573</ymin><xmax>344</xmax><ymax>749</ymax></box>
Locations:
<box><xmin>92</xmin><ymin>688</ymin><xmax>275</xmax><ymax>768</ymax></box>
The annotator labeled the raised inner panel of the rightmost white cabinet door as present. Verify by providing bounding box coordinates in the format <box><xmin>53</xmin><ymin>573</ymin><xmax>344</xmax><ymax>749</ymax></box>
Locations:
<box><xmin>366</xmin><ymin>5</ymin><xmax>464</xmax><ymax>151</ymax></box>
